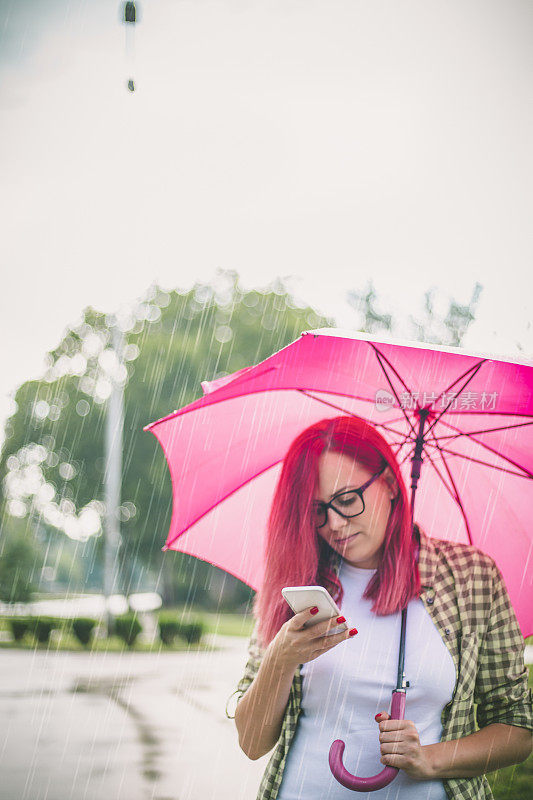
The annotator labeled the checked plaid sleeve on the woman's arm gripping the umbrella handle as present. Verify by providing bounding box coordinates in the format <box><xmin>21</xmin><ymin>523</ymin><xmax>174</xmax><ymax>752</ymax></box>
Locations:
<box><xmin>474</xmin><ymin>561</ymin><xmax>533</xmax><ymax>730</ymax></box>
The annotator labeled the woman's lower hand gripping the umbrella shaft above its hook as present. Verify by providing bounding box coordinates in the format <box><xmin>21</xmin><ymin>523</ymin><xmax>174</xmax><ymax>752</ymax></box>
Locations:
<box><xmin>376</xmin><ymin>712</ymin><xmax>433</xmax><ymax>780</ymax></box>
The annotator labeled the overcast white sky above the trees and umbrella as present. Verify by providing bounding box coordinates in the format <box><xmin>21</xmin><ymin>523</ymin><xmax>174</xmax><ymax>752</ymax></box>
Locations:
<box><xmin>0</xmin><ymin>0</ymin><xmax>533</xmax><ymax>450</ymax></box>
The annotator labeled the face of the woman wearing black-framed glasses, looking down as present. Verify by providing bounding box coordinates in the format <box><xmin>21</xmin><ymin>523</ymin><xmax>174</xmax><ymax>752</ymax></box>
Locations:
<box><xmin>315</xmin><ymin>452</ymin><xmax>398</xmax><ymax>569</ymax></box>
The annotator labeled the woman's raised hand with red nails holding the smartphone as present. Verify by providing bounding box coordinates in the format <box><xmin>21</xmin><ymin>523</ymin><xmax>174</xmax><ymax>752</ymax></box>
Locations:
<box><xmin>269</xmin><ymin>606</ymin><xmax>357</xmax><ymax>668</ymax></box>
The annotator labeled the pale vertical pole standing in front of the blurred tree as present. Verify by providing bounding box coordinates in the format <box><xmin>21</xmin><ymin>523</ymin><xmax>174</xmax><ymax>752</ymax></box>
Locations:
<box><xmin>104</xmin><ymin>320</ymin><xmax>124</xmax><ymax>635</ymax></box>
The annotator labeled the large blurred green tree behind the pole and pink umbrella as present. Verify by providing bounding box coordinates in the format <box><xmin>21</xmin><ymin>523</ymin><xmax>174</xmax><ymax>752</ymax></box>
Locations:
<box><xmin>0</xmin><ymin>270</ymin><xmax>334</xmax><ymax>607</ymax></box>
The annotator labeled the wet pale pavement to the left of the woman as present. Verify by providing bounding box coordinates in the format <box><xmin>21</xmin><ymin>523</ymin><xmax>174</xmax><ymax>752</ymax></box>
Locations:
<box><xmin>0</xmin><ymin>637</ymin><xmax>268</xmax><ymax>800</ymax></box>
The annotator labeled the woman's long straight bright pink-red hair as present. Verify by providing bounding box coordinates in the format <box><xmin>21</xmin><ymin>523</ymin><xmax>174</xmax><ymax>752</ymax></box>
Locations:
<box><xmin>254</xmin><ymin>416</ymin><xmax>420</xmax><ymax>647</ymax></box>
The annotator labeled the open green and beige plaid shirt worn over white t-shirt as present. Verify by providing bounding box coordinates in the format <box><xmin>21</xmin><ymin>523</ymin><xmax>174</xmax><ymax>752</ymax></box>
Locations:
<box><xmin>233</xmin><ymin>531</ymin><xmax>533</xmax><ymax>800</ymax></box>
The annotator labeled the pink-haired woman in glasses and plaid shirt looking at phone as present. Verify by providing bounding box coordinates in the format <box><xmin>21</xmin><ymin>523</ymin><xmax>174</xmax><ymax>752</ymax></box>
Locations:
<box><xmin>235</xmin><ymin>417</ymin><xmax>533</xmax><ymax>800</ymax></box>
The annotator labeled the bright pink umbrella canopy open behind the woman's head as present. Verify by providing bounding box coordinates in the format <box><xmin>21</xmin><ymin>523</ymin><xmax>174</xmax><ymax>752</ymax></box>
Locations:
<box><xmin>145</xmin><ymin>328</ymin><xmax>533</xmax><ymax>636</ymax></box>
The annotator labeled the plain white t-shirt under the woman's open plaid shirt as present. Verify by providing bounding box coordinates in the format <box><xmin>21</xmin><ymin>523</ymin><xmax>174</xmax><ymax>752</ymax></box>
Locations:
<box><xmin>278</xmin><ymin>561</ymin><xmax>456</xmax><ymax>800</ymax></box>
